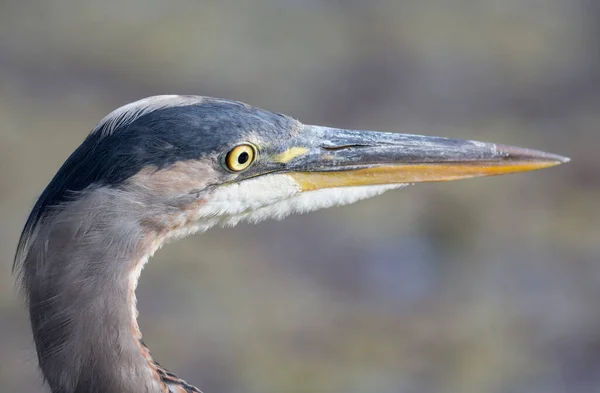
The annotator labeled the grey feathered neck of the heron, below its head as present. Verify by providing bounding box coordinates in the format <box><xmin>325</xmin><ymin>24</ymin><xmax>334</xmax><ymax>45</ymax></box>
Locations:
<box><xmin>22</xmin><ymin>188</ymin><xmax>173</xmax><ymax>393</ymax></box>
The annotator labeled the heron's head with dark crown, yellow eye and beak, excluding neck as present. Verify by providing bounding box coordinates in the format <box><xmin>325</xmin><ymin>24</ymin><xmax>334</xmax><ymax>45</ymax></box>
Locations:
<box><xmin>16</xmin><ymin>96</ymin><xmax>568</xmax><ymax>256</ymax></box>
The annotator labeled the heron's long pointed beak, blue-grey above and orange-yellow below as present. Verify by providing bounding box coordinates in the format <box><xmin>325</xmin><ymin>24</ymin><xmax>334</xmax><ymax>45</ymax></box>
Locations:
<box><xmin>275</xmin><ymin>126</ymin><xmax>569</xmax><ymax>191</ymax></box>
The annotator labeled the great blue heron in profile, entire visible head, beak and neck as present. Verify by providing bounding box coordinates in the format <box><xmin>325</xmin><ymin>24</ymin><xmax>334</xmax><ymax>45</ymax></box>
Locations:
<box><xmin>14</xmin><ymin>96</ymin><xmax>568</xmax><ymax>393</ymax></box>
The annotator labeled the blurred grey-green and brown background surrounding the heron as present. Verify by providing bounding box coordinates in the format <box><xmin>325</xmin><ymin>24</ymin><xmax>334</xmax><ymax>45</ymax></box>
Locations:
<box><xmin>0</xmin><ymin>0</ymin><xmax>600</xmax><ymax>393</ymax></box>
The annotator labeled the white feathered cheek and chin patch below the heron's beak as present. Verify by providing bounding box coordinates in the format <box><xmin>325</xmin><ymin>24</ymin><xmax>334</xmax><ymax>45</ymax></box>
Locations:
<box><xmin>194</xmin><ymin>174</ymin><xmax>404</xmax><ymax>230</ymax></box>
